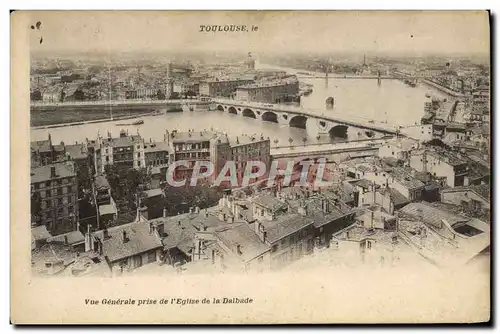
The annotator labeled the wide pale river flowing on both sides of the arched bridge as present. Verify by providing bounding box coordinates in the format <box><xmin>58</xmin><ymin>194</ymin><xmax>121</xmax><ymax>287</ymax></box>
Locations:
<box><xmin>31</xmin><ymin>64</ymin><xmax>444</xmax><ymax>146</ymax></box>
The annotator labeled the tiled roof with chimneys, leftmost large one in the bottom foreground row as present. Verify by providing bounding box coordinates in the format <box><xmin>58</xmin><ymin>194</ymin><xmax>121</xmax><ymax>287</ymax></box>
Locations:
<box><xmin>94</xmin><ymin>222</ymin><xmax>163</xmax><ymax>262</ymax></box>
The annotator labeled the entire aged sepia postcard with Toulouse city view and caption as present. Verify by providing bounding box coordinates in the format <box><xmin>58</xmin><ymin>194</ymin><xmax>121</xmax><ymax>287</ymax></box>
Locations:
<box><xmin>11</xmin><ymin>11</ymin><xmax>491</xmax><ymax>324</ymax></box>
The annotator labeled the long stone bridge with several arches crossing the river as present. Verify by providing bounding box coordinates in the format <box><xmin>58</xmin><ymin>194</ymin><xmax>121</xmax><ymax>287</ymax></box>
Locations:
<box><xmin>212</xmin><ymin>99</ymin><xmax>399</xmax><ymax>140</ymax></box>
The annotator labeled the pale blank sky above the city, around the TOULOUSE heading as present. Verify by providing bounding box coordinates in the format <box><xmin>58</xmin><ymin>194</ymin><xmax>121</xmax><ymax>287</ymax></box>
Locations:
<box><xmin>27</xmin><ymin>11</ymin><xmax>490</xmax><ymax>54</ymax></box>
